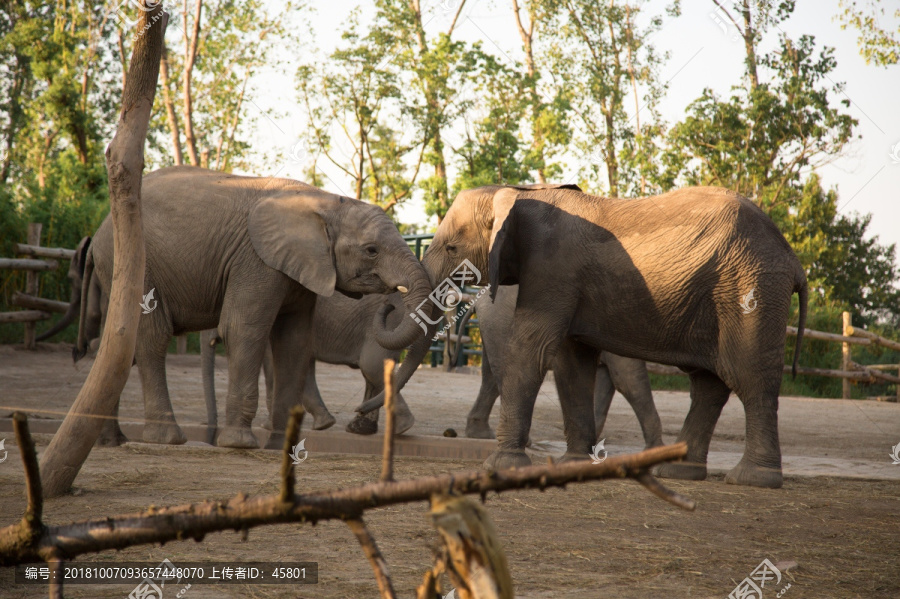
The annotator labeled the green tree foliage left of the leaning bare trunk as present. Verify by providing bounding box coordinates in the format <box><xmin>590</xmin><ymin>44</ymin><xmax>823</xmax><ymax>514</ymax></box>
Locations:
<box><xmin>0</xmin><ymin>2</ymin><xmax>120</xmax><ymax>340</ymax></box>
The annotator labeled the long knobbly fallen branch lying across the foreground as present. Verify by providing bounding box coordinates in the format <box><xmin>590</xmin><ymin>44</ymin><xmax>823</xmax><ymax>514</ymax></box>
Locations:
<box><xmin>0</xmin><ymin>415</ymin><xmax>694</xmax><ymax>566</ymax></box>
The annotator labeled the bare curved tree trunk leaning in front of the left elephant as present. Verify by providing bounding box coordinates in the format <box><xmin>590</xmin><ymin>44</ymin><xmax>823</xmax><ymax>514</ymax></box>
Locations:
<box><xmin>40</xmin><ymin>0</ymin><xmax>168</xmax><ymax>497</ymax></box>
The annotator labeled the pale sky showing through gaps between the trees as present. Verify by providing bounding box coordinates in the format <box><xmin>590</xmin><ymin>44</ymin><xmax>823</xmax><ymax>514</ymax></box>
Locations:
<box><xmin>239</xmin><ymin>0</ymin><xmax>900</xmax><ymax>253</ymax></box>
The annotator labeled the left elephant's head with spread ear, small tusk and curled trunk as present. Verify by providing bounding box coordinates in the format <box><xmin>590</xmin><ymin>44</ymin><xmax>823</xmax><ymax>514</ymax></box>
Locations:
<box><xmin>248</xmin><ymin>184</ymin><xmax>431</xmax><ymax>349</ymax></box>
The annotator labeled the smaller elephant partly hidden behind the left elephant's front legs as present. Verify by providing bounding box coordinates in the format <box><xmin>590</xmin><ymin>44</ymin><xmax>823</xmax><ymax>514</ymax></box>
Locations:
<box><xmin>200</xmin><ymin>293</ymin><xmax>415</xmax><ymax>435</ymax></box>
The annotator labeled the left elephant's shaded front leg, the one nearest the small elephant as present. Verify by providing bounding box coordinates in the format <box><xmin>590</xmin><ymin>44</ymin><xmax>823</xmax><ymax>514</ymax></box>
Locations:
<box><xmin>265</xmin><ymin>304</ymin><xmax>316</xmax><ymax>450</ymax></box>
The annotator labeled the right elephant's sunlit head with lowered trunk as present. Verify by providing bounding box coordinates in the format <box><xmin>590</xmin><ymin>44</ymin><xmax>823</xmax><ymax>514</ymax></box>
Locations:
<box><xmin>357</xmin><ymin>183</ymin><xmax>581</xmax><ymax>412</ymax></box>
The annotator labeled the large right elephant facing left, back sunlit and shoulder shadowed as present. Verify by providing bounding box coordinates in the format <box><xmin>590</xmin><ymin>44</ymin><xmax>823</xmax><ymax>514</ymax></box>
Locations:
<box><xmin>357</xmin><ymin>184</ymin><xmax>808</xmax><ymax>488</ymax></box>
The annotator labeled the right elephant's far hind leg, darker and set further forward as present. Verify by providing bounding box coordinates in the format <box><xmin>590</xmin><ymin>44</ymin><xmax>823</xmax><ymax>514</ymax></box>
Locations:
<box><xmin>655</xmin><ymin>370</ymin><xmax>731</xmax><ymax>480</ymax></box>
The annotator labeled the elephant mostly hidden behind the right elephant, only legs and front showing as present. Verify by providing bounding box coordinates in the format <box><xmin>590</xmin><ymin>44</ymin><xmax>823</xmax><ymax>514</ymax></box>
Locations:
<box><xmin>457</xmin><ymin>285</ymin><xmax>663</xmax><ymax>449</ymax></box>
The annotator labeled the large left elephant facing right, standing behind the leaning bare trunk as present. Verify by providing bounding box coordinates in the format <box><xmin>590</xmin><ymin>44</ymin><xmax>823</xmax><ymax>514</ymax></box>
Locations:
<box><xmin>74</xmin><ymin>166</ymin><xmax>431</xmax><ymax>449</ymax></box>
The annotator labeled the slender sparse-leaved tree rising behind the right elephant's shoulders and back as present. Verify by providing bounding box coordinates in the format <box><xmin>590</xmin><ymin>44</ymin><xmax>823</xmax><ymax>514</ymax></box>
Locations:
<box><xmin>547</xmin><ymin>0</ymin><xmax>677</xmax><ymax>197</ymax></box>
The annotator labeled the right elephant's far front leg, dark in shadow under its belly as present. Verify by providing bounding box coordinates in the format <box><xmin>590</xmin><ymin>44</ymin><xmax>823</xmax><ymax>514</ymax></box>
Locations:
<box><xmin>553</xmin><ymin>339</ymin><xmax>600</xmax><ymax>461</ymax></box>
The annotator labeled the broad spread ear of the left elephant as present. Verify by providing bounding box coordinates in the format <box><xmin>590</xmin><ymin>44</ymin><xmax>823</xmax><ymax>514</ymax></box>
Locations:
<box><xmin>247</xmin><ymin>192</ymin><xmax>337</xmax><ymax>297</ymax></box>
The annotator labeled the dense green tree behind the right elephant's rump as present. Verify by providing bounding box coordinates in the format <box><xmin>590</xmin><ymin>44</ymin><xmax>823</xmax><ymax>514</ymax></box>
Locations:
<box><xmin>658</xmin><ymin>0</ymin><xmax>900</xmax><ymax>324</ymax></box>
